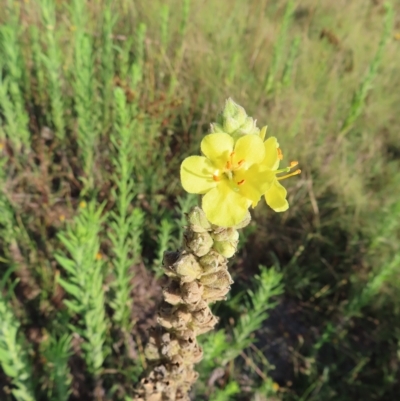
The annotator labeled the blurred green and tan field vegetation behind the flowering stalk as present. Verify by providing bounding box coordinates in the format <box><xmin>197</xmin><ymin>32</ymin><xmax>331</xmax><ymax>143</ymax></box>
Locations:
<box><xmin>0</xmin><ymin>0</ymin><xmax>400</xmax><ymax>401</ymax></box>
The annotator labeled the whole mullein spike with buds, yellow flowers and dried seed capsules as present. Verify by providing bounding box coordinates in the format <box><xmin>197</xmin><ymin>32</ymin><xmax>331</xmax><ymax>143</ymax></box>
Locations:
<box><xmin>134</xmin><ymin>99</ymin><xmax>300</xmax><ymax>401</ymax></box>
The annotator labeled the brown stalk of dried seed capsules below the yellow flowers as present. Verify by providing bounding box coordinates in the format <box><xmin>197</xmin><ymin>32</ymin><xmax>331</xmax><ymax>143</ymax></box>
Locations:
<box><xmin>134</xmin><ymin>207</ymin><xmax>250</xmax><ymax>401</ymax></box>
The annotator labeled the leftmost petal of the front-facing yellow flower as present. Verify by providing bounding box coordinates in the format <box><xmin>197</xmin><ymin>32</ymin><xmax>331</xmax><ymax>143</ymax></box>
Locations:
<box><xmin>181</xmin><ymin>156</ymin><xmax>217</xmax><ymax>194</ymax></box>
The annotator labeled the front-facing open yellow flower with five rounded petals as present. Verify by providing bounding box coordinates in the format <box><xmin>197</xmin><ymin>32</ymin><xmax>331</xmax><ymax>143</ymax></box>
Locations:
<box><xmin>181</xmin><ymin>133</ymin><xmax>272</xmax><ymax>227</ymax></box>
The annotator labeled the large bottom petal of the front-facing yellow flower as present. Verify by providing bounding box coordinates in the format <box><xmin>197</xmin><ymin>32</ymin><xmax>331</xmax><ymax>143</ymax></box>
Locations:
<box><xmin>202</xmin><ymin>181</ymin><xmax>251</xmax><ymax>227</ymax></box>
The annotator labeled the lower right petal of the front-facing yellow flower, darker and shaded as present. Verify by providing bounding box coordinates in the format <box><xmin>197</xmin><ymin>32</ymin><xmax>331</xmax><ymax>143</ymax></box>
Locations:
<box><xmin>234</xmin><ymin>164</ymin><xmax>276</xmax><ymax>204</ymax></box>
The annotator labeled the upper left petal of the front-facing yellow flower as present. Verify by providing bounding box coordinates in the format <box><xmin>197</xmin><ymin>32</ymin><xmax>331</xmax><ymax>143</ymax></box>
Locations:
<box><xmin>201</xmin><ymin>132</ymin><xmax>234</xmax><ymax>169</ymax></box>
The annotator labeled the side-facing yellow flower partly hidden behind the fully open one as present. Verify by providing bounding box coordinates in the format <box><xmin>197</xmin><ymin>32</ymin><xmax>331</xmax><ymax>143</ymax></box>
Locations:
<box><xmin>261</xmin><ymin>136</ymin><xmax>301</xmax><ymax>212</ymax></box>
